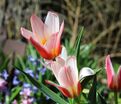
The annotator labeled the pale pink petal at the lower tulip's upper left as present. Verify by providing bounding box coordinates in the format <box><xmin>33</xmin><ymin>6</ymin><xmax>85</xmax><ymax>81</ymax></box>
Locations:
<box><xmin>51</xmin><ymin>61</ymin><xmax>63</xmax><ymax>80</ymax></box>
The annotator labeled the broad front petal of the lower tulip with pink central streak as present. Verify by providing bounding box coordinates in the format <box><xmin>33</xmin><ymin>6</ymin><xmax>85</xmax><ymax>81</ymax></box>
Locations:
<box><xmin>57</xmin><ymin>66</ymin><xmax>77</xmax><ymax>89</ymax></box>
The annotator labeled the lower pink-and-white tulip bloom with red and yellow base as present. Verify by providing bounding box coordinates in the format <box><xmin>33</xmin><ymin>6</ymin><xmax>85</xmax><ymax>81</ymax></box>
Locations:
<box><xmin>46</xmin><ymin>56</ymin><xmax>94</xmax><ymax>98</ymax></box>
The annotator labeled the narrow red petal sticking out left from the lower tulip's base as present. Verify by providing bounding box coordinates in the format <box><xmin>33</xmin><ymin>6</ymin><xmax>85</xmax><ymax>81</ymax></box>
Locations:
<box><xmin>45</xmin><ymin>80</ymin><xmax>72</xmax><ymax>98</ymax></box>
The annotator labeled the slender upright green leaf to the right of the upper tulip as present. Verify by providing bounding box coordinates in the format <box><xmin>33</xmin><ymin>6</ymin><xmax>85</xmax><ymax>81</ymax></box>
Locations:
<box><xmin>74</xmin><ymin>27</ymin><xmax>84</xmax><ymax>60</ymax></box>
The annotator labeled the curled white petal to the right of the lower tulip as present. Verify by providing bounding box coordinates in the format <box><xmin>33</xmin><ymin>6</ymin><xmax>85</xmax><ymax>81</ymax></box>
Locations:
<box><xmin>79</xmin><ymin>67</ymin><xmax>94</xmax><ymax>80</ymax></box>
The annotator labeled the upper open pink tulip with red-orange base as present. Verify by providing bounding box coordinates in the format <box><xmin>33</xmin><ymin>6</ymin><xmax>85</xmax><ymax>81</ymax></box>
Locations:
<box><xmin>21</xmin><ymin>11</ymin><xmax>64</xmax><ymax>60</ymax></box>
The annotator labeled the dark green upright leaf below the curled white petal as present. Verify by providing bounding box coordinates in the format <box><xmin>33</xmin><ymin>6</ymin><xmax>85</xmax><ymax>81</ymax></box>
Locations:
<box><xmin>88</xmin><ymin>75</ymin><xmax>97</xmax><ymax>104</ymax></box>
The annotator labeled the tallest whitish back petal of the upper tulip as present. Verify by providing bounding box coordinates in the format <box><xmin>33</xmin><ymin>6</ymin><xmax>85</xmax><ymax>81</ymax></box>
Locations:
<box><xmin>45</xmin><ymin>11</ymin><xmax>59</xmax><ymax>34</ymax></box>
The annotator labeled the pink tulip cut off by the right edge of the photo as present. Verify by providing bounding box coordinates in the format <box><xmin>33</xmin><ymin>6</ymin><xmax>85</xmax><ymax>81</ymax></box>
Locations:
<box><xmin>105</xmin><ymin>55</ymin><xmax>121</xmax><ymax>91</ymax></box>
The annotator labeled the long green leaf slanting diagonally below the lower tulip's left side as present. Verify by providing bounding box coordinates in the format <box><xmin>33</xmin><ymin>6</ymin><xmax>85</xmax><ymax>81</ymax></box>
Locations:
<box><xmin>17</xmin><ymin>68</ymin><xmax>68</xmax><ymax>104</ymax></box>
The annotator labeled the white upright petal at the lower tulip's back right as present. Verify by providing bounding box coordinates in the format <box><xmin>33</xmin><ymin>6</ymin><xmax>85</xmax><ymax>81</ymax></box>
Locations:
<box><xmin>66</xmin><ymin>56</ymin><xmax>79</xmax><ymax>84</ymax></box>
